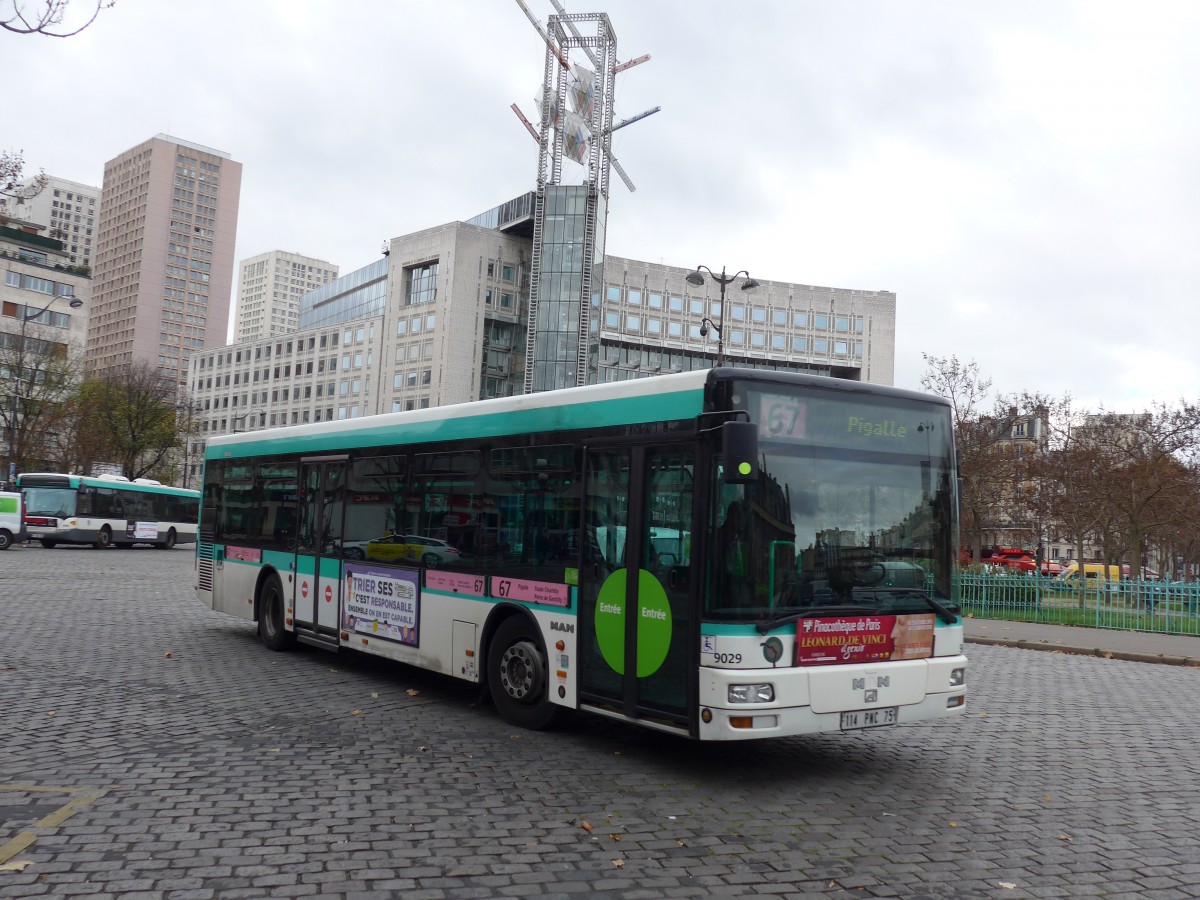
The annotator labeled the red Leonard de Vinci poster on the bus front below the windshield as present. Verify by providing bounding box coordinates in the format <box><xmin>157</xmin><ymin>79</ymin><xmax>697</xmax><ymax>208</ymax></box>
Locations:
<box><xmin>796</xmin><ymin>613</ymin><xmax>934</xmax><ymax>666</ymax></box>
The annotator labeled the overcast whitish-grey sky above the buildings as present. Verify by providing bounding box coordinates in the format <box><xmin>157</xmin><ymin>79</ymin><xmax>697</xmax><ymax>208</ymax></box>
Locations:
<box><xmin>9</xmin><ymin>0</ymin><xmax>1200</xmax><ymax>410</ymax></box>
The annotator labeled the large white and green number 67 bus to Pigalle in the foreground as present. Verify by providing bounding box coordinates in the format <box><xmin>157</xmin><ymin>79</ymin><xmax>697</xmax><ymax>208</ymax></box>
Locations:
<box><xmin>197</xmin><ymin>368</ymin><xmax>966</xmax><ymax>740</ymax></box>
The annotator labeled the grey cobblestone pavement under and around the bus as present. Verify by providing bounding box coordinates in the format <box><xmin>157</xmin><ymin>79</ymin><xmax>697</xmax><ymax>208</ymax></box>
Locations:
<box><xmin>0</xmin><ymin>546</ymin><xmax>1200</xmax><ymax>900</ymax></box>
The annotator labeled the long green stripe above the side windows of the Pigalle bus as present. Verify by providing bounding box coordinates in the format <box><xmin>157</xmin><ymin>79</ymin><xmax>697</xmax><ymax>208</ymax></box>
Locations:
<box><xmin>205</xmin><ymin>390</ymin><xmax>704</xmax><ymax>460</ymax></box>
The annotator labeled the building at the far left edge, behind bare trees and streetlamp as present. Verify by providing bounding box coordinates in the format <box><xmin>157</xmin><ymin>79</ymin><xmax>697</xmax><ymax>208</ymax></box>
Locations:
<box><xmin>0</xmin><ymin>218</ymin><xmax>91</xmax><ymax>481</ymax></box>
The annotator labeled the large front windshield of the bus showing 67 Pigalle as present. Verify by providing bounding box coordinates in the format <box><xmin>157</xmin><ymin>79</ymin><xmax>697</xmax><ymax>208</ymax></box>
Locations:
<box><xmin>706</xmin><ymin>388</ymin><xmax>956</xmax><ymax>620</ymax></box>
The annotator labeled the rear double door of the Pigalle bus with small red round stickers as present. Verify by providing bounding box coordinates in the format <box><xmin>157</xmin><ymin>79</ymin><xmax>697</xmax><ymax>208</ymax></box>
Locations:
<box><xmin>292</xmin><ymin>456</ymin><xmax>346</xmax><ymax>646</ymax></box>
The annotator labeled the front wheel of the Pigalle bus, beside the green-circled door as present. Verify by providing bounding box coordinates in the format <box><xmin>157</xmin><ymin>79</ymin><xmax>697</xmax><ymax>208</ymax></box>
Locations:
<box><xmin>487</xmin><ymin>616</ymin><xmax>562</xmax><ymax>731</ymax></box>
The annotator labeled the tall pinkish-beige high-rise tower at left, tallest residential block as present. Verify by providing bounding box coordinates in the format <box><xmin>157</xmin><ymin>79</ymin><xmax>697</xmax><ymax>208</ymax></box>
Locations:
<box><xmin>85</xmin><ymin>134</ymin><xmax>241</xmax><ymax>386</ymax></box>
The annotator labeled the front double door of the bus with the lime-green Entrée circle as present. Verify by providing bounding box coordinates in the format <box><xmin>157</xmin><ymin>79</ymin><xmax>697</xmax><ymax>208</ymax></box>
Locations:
<box><xmin>578</xmin><ymin>446</ymin><xmax>698</xmax><ymax>727</ymax></box>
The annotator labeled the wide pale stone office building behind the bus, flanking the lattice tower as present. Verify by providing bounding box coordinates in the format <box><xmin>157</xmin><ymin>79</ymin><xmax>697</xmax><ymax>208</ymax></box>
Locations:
<box><xmin>188</xmin><ymin>203</ymin><xmax>895</xmax><ymax>487</ymax></box>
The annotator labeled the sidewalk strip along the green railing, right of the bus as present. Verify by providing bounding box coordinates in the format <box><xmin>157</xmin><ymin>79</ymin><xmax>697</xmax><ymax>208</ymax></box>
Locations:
<box><xmin>962</xmin><ymin>618</ymin><xmax>1200</xmax><ymax>666</ymax></box>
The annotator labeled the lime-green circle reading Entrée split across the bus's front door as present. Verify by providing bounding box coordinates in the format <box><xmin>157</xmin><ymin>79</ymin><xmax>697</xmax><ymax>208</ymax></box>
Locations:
<box><xmin>595</xmin><ymin>569</ymin><xmax>671</xmax><ymax>678</ymax></box>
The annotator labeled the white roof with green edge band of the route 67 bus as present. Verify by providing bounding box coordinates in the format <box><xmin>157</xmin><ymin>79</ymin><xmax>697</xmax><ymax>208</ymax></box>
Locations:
<box><xmin>204</xmin><ymin>368</ymin><xmax>946</xmax><ymax>460</ymax></box>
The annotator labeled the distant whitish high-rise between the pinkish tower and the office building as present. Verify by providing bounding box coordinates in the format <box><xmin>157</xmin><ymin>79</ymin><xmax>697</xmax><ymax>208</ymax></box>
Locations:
<box><xmin>234</xmin><ymin>250</ymin><xmax>337</xmax><ymax>343</ymax></box>
